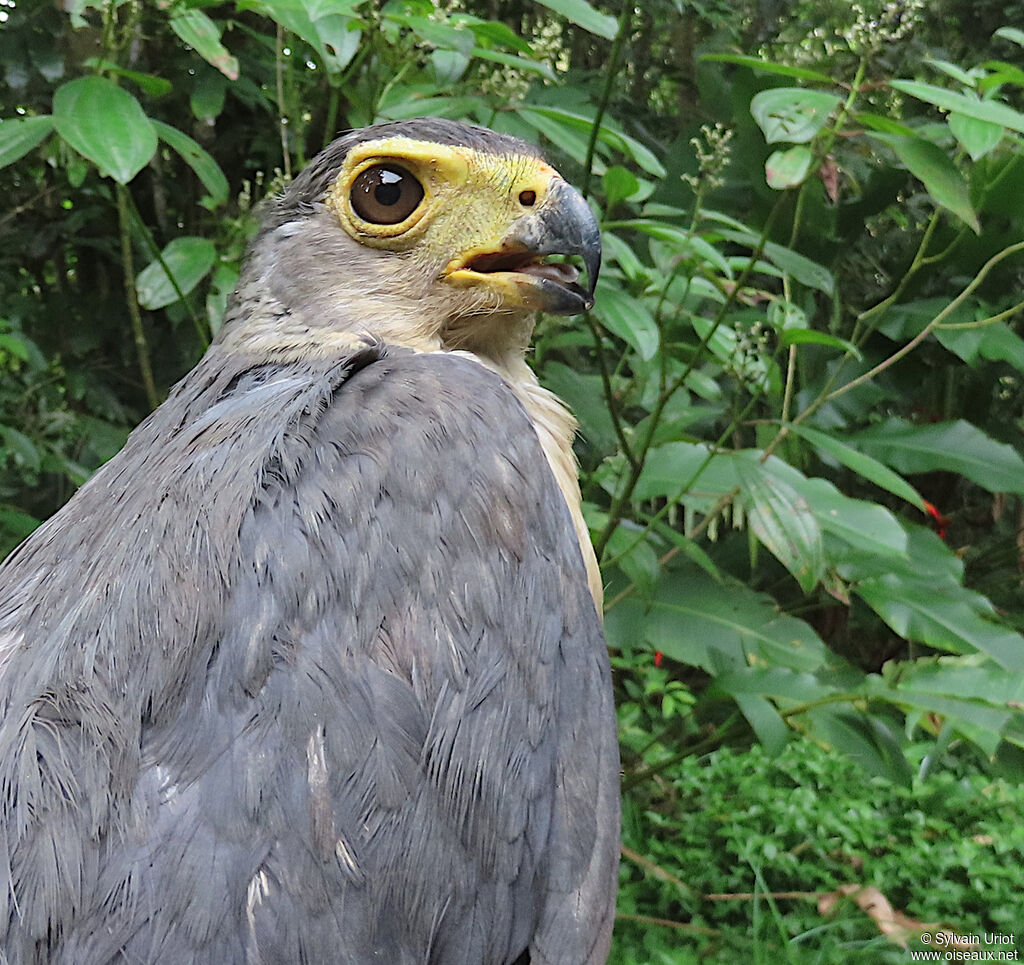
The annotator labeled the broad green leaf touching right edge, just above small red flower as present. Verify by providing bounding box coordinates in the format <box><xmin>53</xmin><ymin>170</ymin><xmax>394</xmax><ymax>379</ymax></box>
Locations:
<box><xmin>849</xmin><ymin>419</ymin><xmax>1024</xmax><ymax>493</ymax></box>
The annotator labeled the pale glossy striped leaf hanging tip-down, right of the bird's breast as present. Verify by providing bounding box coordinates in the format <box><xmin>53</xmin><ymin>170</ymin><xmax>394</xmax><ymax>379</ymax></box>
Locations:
<box><xmin>736</xmin><ymin>459</ymin><xmax>825</xmax><ymax>593</ymax></box>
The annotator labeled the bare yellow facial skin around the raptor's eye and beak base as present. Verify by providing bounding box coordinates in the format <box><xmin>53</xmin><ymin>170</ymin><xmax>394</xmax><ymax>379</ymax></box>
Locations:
<box><xmin>326</xmin><ymin>137</ymin><xmax>599</xmax><ymax>313</ymax></box>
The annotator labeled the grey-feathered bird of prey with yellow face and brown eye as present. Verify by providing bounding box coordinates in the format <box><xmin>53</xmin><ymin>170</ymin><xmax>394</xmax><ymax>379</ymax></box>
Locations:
<box><xmin>0</xmin><ymin>119</ymin><xmax>618</xmax><ymax>965</ymax></box>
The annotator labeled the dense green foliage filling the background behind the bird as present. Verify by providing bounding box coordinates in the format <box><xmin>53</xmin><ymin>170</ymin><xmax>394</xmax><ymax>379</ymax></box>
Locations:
<box><xmin>0</xmin><ymin>0</ymin><xmax>1024</xmax><ymax>963</ymax></box>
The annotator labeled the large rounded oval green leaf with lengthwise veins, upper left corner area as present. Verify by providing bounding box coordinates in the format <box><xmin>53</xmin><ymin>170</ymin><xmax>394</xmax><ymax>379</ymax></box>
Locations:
<box><xmin>53</xmin><ymin>77</ymin><xmax>157</xmax><ymax>184</ymax></box>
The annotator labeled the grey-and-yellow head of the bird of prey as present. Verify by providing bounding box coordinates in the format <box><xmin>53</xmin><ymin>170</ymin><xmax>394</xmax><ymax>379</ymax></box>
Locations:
<box><xmin>221</xmin><ymin>118</ymin><xmax>601</xmax><ymax>355</ymax></box>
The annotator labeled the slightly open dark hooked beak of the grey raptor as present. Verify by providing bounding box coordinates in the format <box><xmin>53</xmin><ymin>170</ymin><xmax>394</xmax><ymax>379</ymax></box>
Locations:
<box><xmin>445</xmin><ymin>178</ymin><xmax>601</xmax><ymax>314</ymax></box>
